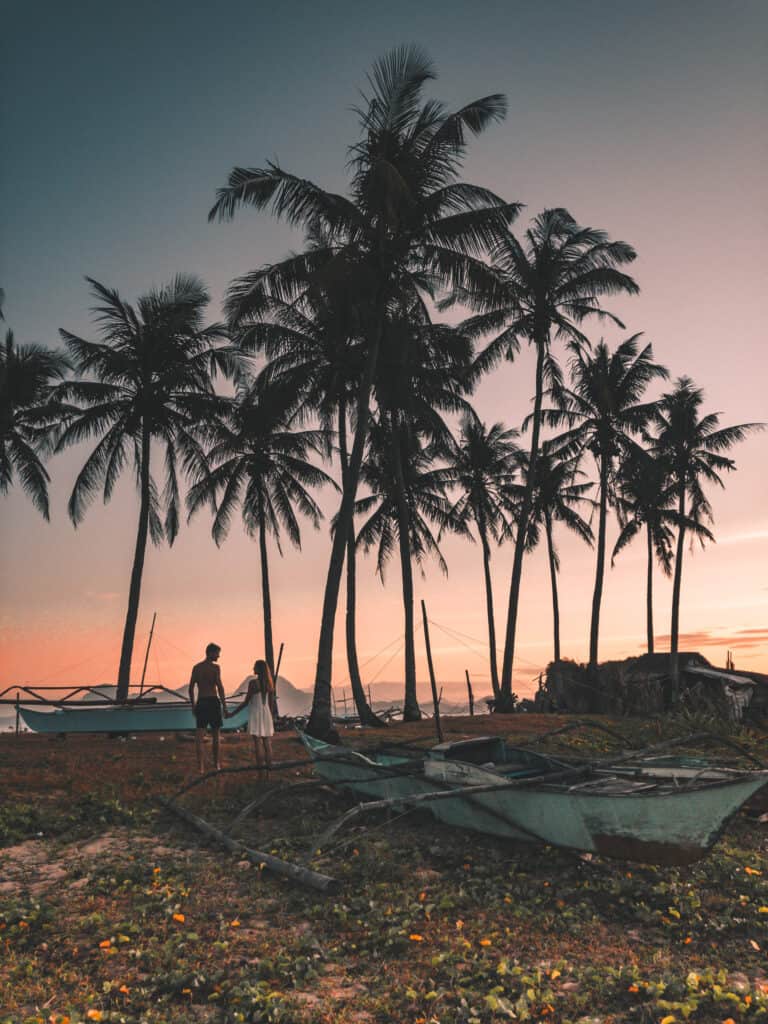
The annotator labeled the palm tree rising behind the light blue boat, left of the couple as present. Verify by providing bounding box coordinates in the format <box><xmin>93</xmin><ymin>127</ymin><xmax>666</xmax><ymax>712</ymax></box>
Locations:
<box><xmin>56</xmin><ymin>274</ymin><xmax>237</xmax><ymax>700</ymax></box>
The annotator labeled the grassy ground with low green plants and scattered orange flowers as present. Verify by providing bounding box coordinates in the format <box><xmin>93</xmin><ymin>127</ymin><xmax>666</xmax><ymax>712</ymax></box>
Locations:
<box><xmin>0</xmin><ymin>716</ymin><xmax>768</xmax><ymax>1024</ymax></box>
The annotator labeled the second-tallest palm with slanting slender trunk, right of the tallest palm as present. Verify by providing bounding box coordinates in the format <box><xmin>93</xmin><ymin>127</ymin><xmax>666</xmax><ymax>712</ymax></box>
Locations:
<box><xmin>457</xmin><ymin>209</ymin><xmax>639</xmax><ymax>712</ymax></box>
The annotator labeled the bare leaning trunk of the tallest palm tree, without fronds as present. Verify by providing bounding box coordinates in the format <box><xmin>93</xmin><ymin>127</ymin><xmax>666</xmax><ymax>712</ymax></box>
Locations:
<box><xmin>307</xmin><ymin>311</ymin><xmax>384</xmax><ymax>739</ymax></box>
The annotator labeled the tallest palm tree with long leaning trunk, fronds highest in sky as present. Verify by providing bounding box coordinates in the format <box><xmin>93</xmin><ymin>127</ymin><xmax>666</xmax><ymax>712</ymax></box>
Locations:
<box><xmin>210</xmin><ymin>47</ymin><xmax>519</xmax><ymax>735</ymax></box>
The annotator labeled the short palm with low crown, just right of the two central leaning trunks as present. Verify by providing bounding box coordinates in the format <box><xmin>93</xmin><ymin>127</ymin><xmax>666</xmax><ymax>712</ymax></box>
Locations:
<box><xmin>355</xmin><ymin>423</ymin><xmax>464</xmax><ymax>722</ymax></box>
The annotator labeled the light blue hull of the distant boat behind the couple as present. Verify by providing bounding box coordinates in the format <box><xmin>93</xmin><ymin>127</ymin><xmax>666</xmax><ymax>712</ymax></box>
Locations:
<box><xmin>18</xmin><ymin>701</ymin><xmax>248</xmax><ymax>734</ymax></box>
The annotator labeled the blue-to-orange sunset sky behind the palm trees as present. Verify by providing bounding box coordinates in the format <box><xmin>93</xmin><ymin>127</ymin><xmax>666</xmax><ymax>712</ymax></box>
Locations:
<box><xmin>0</xmin><ymin>0</ymin><xmax>768</xmax><ymax>695</ymax></box>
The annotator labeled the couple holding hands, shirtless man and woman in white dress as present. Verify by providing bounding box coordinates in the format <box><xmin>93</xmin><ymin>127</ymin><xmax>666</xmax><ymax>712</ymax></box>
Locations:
<box><xmin>189</xmin><ymin>643</ymin><xmax>274</xmax><ymax>774</ymax></box>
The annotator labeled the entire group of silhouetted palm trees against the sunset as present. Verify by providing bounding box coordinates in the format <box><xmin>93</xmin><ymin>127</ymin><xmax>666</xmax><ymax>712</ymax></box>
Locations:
<box><xmin>0</xmin><ymin>47</ymin><xmax>755</xmax><ymax>735</ymax></box>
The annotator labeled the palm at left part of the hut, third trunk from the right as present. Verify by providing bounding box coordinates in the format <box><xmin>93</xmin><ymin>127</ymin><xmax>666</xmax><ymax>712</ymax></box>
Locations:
<box><xmin>546</xmin><ymin>334</ymin><xmax>669</xmax><ymax>667</ymax></box>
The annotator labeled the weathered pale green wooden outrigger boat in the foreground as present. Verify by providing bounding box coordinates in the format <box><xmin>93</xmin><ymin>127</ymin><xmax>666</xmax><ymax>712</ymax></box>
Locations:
<box><xmin>302</xmin><ymin>735</ymin><xmax>768</xmax><ymax>865</ymax></box>
